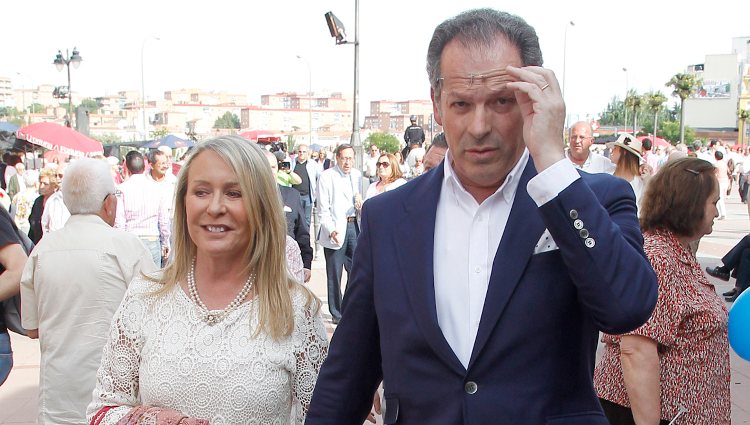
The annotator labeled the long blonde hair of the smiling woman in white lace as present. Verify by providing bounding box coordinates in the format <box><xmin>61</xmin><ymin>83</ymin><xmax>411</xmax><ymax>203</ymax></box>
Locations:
<box><xmin>159</xmin><ymin>136</ymin><xmax>320</xmax><ymax>340</ymax></box>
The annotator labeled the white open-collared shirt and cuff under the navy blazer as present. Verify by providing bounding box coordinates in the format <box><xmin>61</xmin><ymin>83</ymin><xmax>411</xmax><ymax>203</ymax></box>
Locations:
<box><xmin>433</xmin><ymin>150</ymin><xmax>580</xmax><ymax>367</ymax></box>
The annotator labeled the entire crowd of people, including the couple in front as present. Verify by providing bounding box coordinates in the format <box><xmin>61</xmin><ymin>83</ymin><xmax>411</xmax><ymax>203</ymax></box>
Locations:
<box><xmin>0</xmin><ymin>9</ymin><xmax>750</xmax><ymax>425</ymax></box>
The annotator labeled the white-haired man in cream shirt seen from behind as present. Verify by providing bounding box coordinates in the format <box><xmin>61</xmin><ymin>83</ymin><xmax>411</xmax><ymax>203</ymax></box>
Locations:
<box><xmin>21</xmin><ymin>159</ymin><xmax>157</xmax><ymax>424</ymax></box>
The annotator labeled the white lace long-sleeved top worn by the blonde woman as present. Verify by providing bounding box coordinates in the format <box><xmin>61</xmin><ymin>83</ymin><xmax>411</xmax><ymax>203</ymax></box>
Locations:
<box><xmin>87</xmin><ymin>279</ymin><xmax>328</xmax><ymax>425</ymax></box>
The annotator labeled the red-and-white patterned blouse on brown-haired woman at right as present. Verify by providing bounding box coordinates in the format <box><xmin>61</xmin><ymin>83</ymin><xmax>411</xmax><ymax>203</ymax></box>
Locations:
<box><xmin>594</xmin><ymin>231</ymin><xmax>731</xmax><ymax>425</ymax></box>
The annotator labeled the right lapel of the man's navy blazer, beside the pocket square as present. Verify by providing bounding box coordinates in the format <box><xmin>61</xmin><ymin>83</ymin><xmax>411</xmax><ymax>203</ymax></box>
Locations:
<box><xmin>469</xmin><ymin>158</ymin><xmax>545</xmax><ymax>368</ymax></box>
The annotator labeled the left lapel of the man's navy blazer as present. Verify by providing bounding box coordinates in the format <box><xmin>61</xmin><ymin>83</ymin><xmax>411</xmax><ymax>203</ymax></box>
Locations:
<box><xmin>394</xmin><ymin>167</ymin><xmax>466</xmax><ymax>375</ymax></box>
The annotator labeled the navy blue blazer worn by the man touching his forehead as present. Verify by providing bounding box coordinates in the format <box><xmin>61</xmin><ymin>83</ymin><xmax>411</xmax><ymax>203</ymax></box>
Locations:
<box><xmin>306</xmin><ymin>160</ymin><xmax>657</xmax><ymax>425</ymax></box>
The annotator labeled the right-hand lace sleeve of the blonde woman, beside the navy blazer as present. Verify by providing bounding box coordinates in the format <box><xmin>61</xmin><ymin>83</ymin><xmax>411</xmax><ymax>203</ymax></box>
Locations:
<box><xmin>292</xmin><ymin>299</ymin><xmax>328</xmax><ymax>425</ymax></box>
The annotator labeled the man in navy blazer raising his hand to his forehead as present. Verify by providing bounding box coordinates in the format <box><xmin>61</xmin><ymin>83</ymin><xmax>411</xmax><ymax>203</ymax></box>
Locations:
<box><xmin>306</xmin><ymin>9</ymin><xmax>656</xmax><ymax>425</ymax></box>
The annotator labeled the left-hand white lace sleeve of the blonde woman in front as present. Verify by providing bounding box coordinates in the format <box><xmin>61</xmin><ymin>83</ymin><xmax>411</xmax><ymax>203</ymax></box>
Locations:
<box><xmin>86</xmin><ymin>282</ymin><xmax>146</xmax><ymax>425</ymax></box>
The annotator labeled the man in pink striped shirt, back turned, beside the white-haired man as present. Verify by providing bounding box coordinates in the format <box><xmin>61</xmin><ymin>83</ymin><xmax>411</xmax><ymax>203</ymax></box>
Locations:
<box><xmin>115</xmin><ymin>151</ymin><xmax>172</xmax><ymax>265</ymax></box>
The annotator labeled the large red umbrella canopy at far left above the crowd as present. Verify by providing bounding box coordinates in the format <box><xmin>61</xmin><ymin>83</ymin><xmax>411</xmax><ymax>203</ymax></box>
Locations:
<box><xmin>16</xmin><ymin>122</ymin><xmax>104</xmax><ymax>156</ymax></box>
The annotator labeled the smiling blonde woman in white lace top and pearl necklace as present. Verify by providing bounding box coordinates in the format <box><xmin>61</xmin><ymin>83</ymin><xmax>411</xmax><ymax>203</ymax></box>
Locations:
<box><xmin>88</xmin><ymin>136</ymin><xmax>328</xmax><ymax>424</ymax></box>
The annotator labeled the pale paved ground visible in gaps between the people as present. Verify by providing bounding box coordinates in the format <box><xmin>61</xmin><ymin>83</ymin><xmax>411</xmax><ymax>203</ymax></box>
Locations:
<box><xmin>0</xmin><ymin>192</ymin><xmax>750</xmax><ymax>424</ymax></box>
